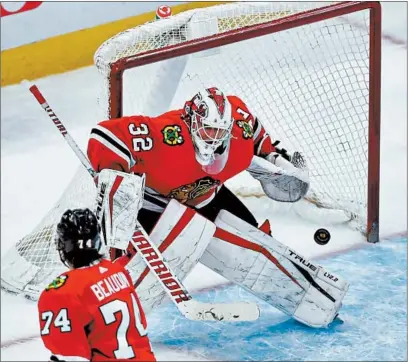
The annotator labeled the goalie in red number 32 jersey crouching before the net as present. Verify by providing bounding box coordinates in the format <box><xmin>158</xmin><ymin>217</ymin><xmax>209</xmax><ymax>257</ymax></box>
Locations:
<box><xmin>88</xmin><ymin>88</ymin><xmax>348</xmax><ymax>327</ymax></box>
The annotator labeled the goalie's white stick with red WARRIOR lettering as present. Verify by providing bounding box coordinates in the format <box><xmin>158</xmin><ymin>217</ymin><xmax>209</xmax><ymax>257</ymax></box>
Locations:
<box><xmin>29</xmin><ymin>85</ymin><xmax>259</xmax><ymax>322</ymax></box>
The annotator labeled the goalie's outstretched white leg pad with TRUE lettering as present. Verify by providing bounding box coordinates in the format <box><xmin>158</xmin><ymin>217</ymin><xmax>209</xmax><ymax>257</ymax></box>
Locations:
<box><xmin>200</xmin><ymin>210</ymin><xmax>348</xmax><ymax>327</ymax></box>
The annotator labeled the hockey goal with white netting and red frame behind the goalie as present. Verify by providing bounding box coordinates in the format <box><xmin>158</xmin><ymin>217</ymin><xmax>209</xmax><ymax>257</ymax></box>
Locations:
<box><xmin>2</xmin><ymin>2</ymin><xmax>381</xmax><ymax>298</ymax></box>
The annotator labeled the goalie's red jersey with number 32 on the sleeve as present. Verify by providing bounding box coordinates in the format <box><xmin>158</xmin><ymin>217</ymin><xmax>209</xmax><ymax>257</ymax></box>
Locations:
<box><xmin>88</xmin><ymin>96</ymin><xmax>274</xmax><ymax>208</ymax></box>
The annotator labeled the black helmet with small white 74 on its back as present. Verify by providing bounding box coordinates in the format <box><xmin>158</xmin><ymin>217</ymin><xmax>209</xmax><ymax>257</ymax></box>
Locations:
<box><xmin>55</xmin><ymin>209</ymin><xmax>102</xmax><ymax>269</ymax></box>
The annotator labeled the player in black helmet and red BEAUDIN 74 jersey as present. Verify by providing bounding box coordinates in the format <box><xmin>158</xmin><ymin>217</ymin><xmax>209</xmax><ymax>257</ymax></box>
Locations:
<box><xmin>38</xmin><ymin>209</ymin><xmax>155</xmax><ymax>361</ymax></box>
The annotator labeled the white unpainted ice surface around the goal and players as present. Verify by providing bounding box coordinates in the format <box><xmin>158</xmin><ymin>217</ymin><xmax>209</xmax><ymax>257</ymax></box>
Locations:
<box><xmin>1</xmin><ymin>4</ymin><xmax>407</xmax><ymax>361</ymax></box>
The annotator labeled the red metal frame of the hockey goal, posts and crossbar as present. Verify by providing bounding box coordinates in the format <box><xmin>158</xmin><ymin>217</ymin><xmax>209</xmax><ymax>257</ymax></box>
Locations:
<box><xmin>109</xmin><ymin>1</ymin><xmax>381</xmax><ymax>243</ymax></box>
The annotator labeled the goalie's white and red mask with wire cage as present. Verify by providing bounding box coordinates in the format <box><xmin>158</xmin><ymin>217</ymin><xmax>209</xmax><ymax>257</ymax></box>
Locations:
<box><xmin>184</xmin><ymin>87</ymin><xmax>234</xmax><ymax>174</ymax></box>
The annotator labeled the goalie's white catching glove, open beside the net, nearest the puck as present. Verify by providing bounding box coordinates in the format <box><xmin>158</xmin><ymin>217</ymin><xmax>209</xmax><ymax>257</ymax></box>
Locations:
<box><xmin>247</xmin><ymin>141</ymin><xmax>309</xmax><ymax>202</ymax></box>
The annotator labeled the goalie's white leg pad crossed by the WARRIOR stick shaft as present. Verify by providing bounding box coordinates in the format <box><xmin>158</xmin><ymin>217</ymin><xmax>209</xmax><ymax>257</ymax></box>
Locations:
<box><xmin>126</xmin><ymin>200</ymin><xmax>216</xmax><ymax>313</ymax></box>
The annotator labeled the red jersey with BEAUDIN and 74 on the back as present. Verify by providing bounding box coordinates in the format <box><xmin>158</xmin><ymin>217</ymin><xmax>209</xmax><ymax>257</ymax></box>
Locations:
<box><xmin>38</xmin><ymin>259</ymin><xmax>155</xmax><ymax>361</ymax></box>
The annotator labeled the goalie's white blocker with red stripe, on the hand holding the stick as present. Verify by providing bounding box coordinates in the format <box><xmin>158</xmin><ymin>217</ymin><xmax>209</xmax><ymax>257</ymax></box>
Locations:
<box><xmin>96</xmin><ymin>169</ymin><xmax>145</xmax><ymax>250</ymax></box>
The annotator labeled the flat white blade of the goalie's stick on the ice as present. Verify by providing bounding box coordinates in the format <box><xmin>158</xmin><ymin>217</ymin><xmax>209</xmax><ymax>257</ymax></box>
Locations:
<box><xmin>181</xmin><ymin>300</ymin><xmax>260</xmax><ymax>322</ymax></box>
